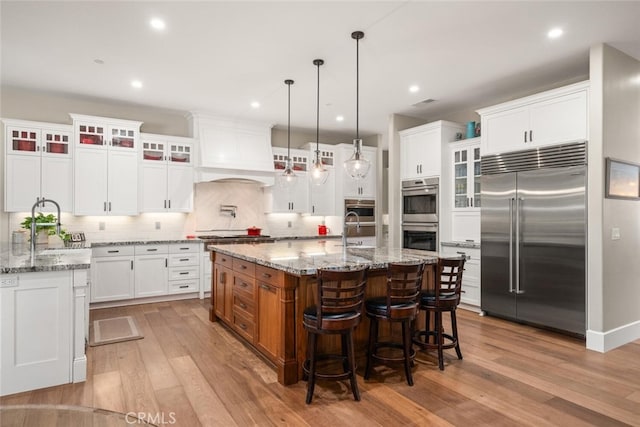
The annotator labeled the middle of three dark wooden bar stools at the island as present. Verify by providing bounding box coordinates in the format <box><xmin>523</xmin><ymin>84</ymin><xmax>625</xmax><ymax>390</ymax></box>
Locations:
<box><xmin>364</xmin><ymin>262</ymin><xmax>424</xmax><ymax>386</ymax></box>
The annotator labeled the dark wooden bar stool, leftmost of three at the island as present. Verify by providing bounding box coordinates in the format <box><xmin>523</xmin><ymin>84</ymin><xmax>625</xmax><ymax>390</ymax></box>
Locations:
<box><xmin>303</xmin><ymin>266</ymin><xmax>368</xmax><ymax>404</ymax></box>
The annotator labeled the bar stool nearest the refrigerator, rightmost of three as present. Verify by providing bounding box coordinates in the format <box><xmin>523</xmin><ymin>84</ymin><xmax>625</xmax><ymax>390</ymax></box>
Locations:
<box><xmin>413</xmin><ymin>257</ymin><xmax>465</xmax><ymax>371</ymax></box>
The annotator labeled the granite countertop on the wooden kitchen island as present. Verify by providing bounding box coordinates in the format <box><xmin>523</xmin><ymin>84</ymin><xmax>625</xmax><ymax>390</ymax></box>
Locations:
<box><xmin>208</xmin><ymin>240</ymin><xmax>438</xmax><ymax>276</ymax></box>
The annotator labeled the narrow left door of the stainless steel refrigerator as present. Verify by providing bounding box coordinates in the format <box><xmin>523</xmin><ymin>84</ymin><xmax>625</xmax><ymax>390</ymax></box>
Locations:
<box><xmin>480</xmin><ymin>173</ymin><xmax>516</xmax><ymax>319</ymax></box>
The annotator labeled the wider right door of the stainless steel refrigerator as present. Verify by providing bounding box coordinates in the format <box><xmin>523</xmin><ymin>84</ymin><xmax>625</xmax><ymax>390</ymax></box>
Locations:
<box><xmin>516</xmin><ymin>166</ymin><xmax>586</xmax><ymax>335</ymax></box>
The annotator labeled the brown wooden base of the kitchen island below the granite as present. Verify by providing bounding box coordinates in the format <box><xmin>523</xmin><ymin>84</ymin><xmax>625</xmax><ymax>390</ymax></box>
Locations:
<box><xmin>209</xmin><ymin>245</ymin><xmax>437</xmax><ymax>385</ymax></box>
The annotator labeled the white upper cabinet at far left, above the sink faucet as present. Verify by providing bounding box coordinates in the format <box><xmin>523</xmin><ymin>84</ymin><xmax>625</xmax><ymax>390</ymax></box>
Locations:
<box><xmin>3</xmin><ymin>119</ymin><xmax>73</xmax><ymax>212</ymax></box>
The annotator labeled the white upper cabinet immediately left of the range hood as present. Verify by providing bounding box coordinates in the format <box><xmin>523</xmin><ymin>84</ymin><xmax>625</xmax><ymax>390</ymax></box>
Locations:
<box><xmin>138</xmin><ymin>133</ymin><xmax>194</xmax><ymax>212</ymax></box>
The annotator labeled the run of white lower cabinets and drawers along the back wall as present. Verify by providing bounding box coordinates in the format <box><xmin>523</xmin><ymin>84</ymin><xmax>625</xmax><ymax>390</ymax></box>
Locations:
<box><xmin>91</xmin><ymin>242</ymin><xmax>202</xmax><ymax>302</ymax></box>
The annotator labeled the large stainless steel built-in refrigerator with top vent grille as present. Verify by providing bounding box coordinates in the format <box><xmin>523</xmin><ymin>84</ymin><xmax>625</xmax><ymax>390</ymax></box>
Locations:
<box><xmin>481</xmin><ymin>142</ymin><xmax>586</xmax><ymax>336</ymax></box>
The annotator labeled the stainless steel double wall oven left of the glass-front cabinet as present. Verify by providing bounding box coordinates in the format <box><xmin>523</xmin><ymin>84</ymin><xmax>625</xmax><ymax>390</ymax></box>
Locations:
<box><xmin>402</xmin><ymin>178</ymin><xmax>440</xmax><ymax>251</ymax></box>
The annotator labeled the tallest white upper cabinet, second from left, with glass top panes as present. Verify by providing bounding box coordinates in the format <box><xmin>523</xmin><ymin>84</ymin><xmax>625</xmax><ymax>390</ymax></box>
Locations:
<box><xmin>71</xmin><ymin>114</ymin><xmax>141</xmax><ymax>215</ymax></box>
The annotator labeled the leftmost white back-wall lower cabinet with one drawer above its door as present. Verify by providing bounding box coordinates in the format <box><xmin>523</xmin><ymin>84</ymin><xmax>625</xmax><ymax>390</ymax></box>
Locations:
<box><xmin>90</xmin><ymin>246</ymin><xmax>135</xmax><ymax>302</ymax></box>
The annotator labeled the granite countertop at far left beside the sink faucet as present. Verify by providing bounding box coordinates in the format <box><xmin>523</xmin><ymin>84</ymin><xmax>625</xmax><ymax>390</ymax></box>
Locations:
<box><xmin>0</xmin><ymin>243</ymin><xmax>91</xmax><ymax>274</ymax></box>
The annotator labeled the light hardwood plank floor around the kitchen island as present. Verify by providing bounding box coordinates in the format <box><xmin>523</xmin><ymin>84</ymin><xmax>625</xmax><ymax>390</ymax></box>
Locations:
<box><xmin>0</xmin><ymin>300</ymin><xmax>640</xmax><ymax>427</ymax></box>
